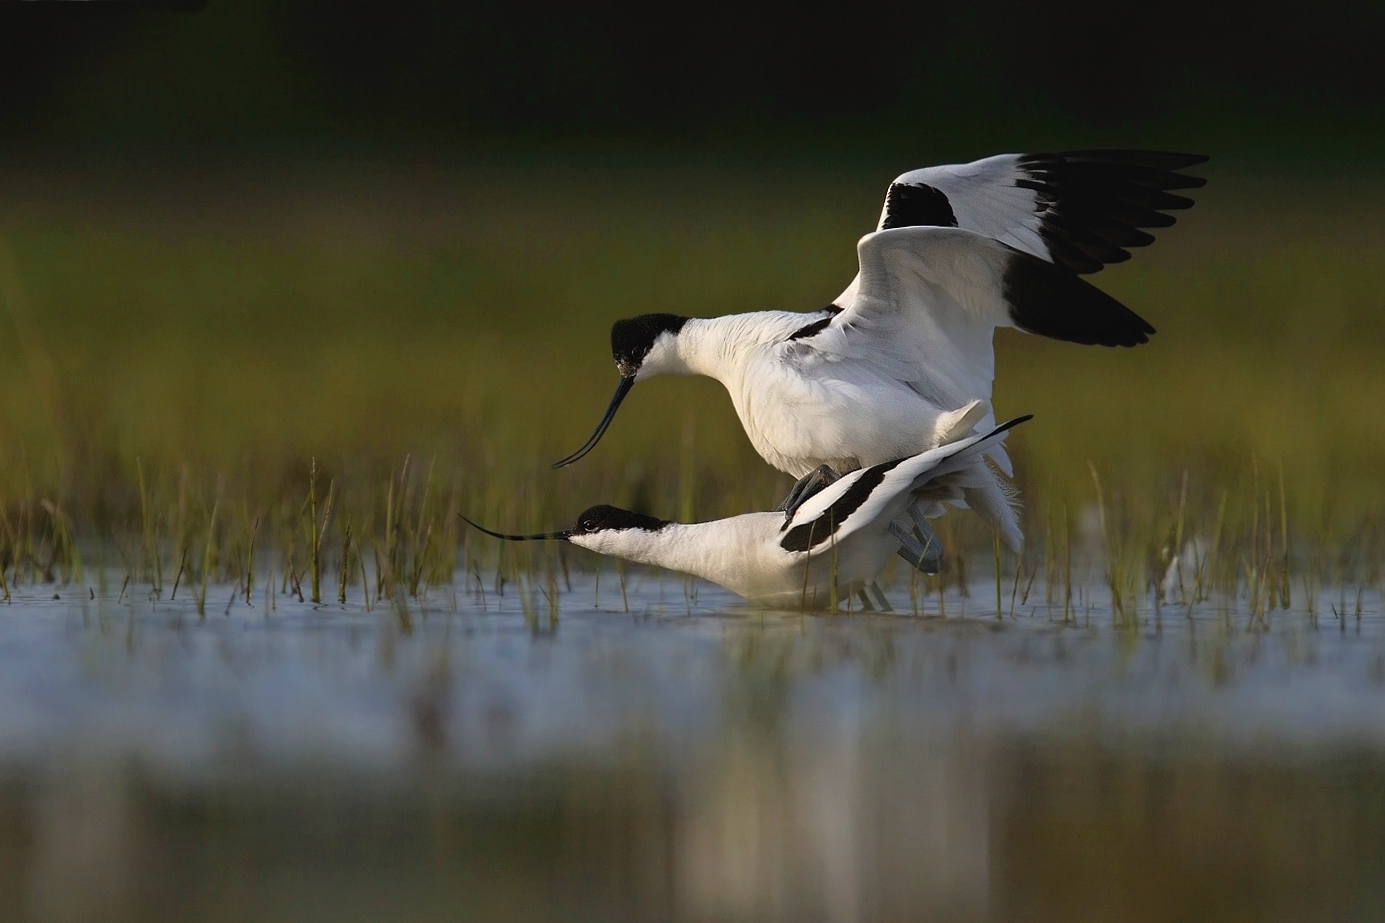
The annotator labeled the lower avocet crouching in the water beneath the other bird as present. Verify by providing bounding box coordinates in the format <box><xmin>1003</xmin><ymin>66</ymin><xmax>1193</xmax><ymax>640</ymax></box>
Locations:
<box><xmin>467</xmin><ymin>417</ymin><xmax>1029</xmax><ymax>608</ymax></box>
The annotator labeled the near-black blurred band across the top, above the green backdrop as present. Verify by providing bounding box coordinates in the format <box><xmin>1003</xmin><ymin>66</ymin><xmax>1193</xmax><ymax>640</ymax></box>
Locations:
<box><xmin>0</xmin><ymin>0</ymin><xmax>1385</xmax><ymax>161</ymax></box>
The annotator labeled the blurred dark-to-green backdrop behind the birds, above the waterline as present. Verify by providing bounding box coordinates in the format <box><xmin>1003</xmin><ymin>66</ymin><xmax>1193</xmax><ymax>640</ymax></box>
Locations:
<box><xmin>0</xmin><ymin>0</ymin><xmax>1385</xmax><ymax>576</ymax></box>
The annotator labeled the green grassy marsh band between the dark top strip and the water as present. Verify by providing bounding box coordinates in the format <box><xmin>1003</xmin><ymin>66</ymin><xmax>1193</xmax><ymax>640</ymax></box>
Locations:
<box><xmin>0</xmin><ymin>154</ymin><xmax>1385</xmax><ymax>607</ymax></box>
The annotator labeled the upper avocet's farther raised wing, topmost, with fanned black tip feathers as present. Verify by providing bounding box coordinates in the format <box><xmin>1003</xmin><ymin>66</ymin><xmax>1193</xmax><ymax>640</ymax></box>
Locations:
<box><xmin>837</xmin><ymin>151</ymin><xmax>1208</xmax><ymax>305</ymax></box>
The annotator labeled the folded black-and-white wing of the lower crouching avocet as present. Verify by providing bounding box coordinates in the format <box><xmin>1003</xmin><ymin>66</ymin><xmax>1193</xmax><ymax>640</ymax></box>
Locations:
<box><xmin>780</xmin><ymin>416</ymin><xmax>1030</xmax><ymax>552</ymax></box>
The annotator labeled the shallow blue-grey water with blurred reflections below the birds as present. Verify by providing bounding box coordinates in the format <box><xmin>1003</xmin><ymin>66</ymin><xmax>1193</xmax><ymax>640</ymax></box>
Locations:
<box><xmin>0</xmin><ymin>575</ymin><xmax>1385</xmax><ymax>920</ymax></box>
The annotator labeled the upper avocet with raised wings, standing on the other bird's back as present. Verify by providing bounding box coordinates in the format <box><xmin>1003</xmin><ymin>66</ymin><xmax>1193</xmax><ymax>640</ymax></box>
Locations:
<box><xmin>555</xmin><ymin>151</ymin><xmax>1206</xmax><ymax>547</ymax></box>
